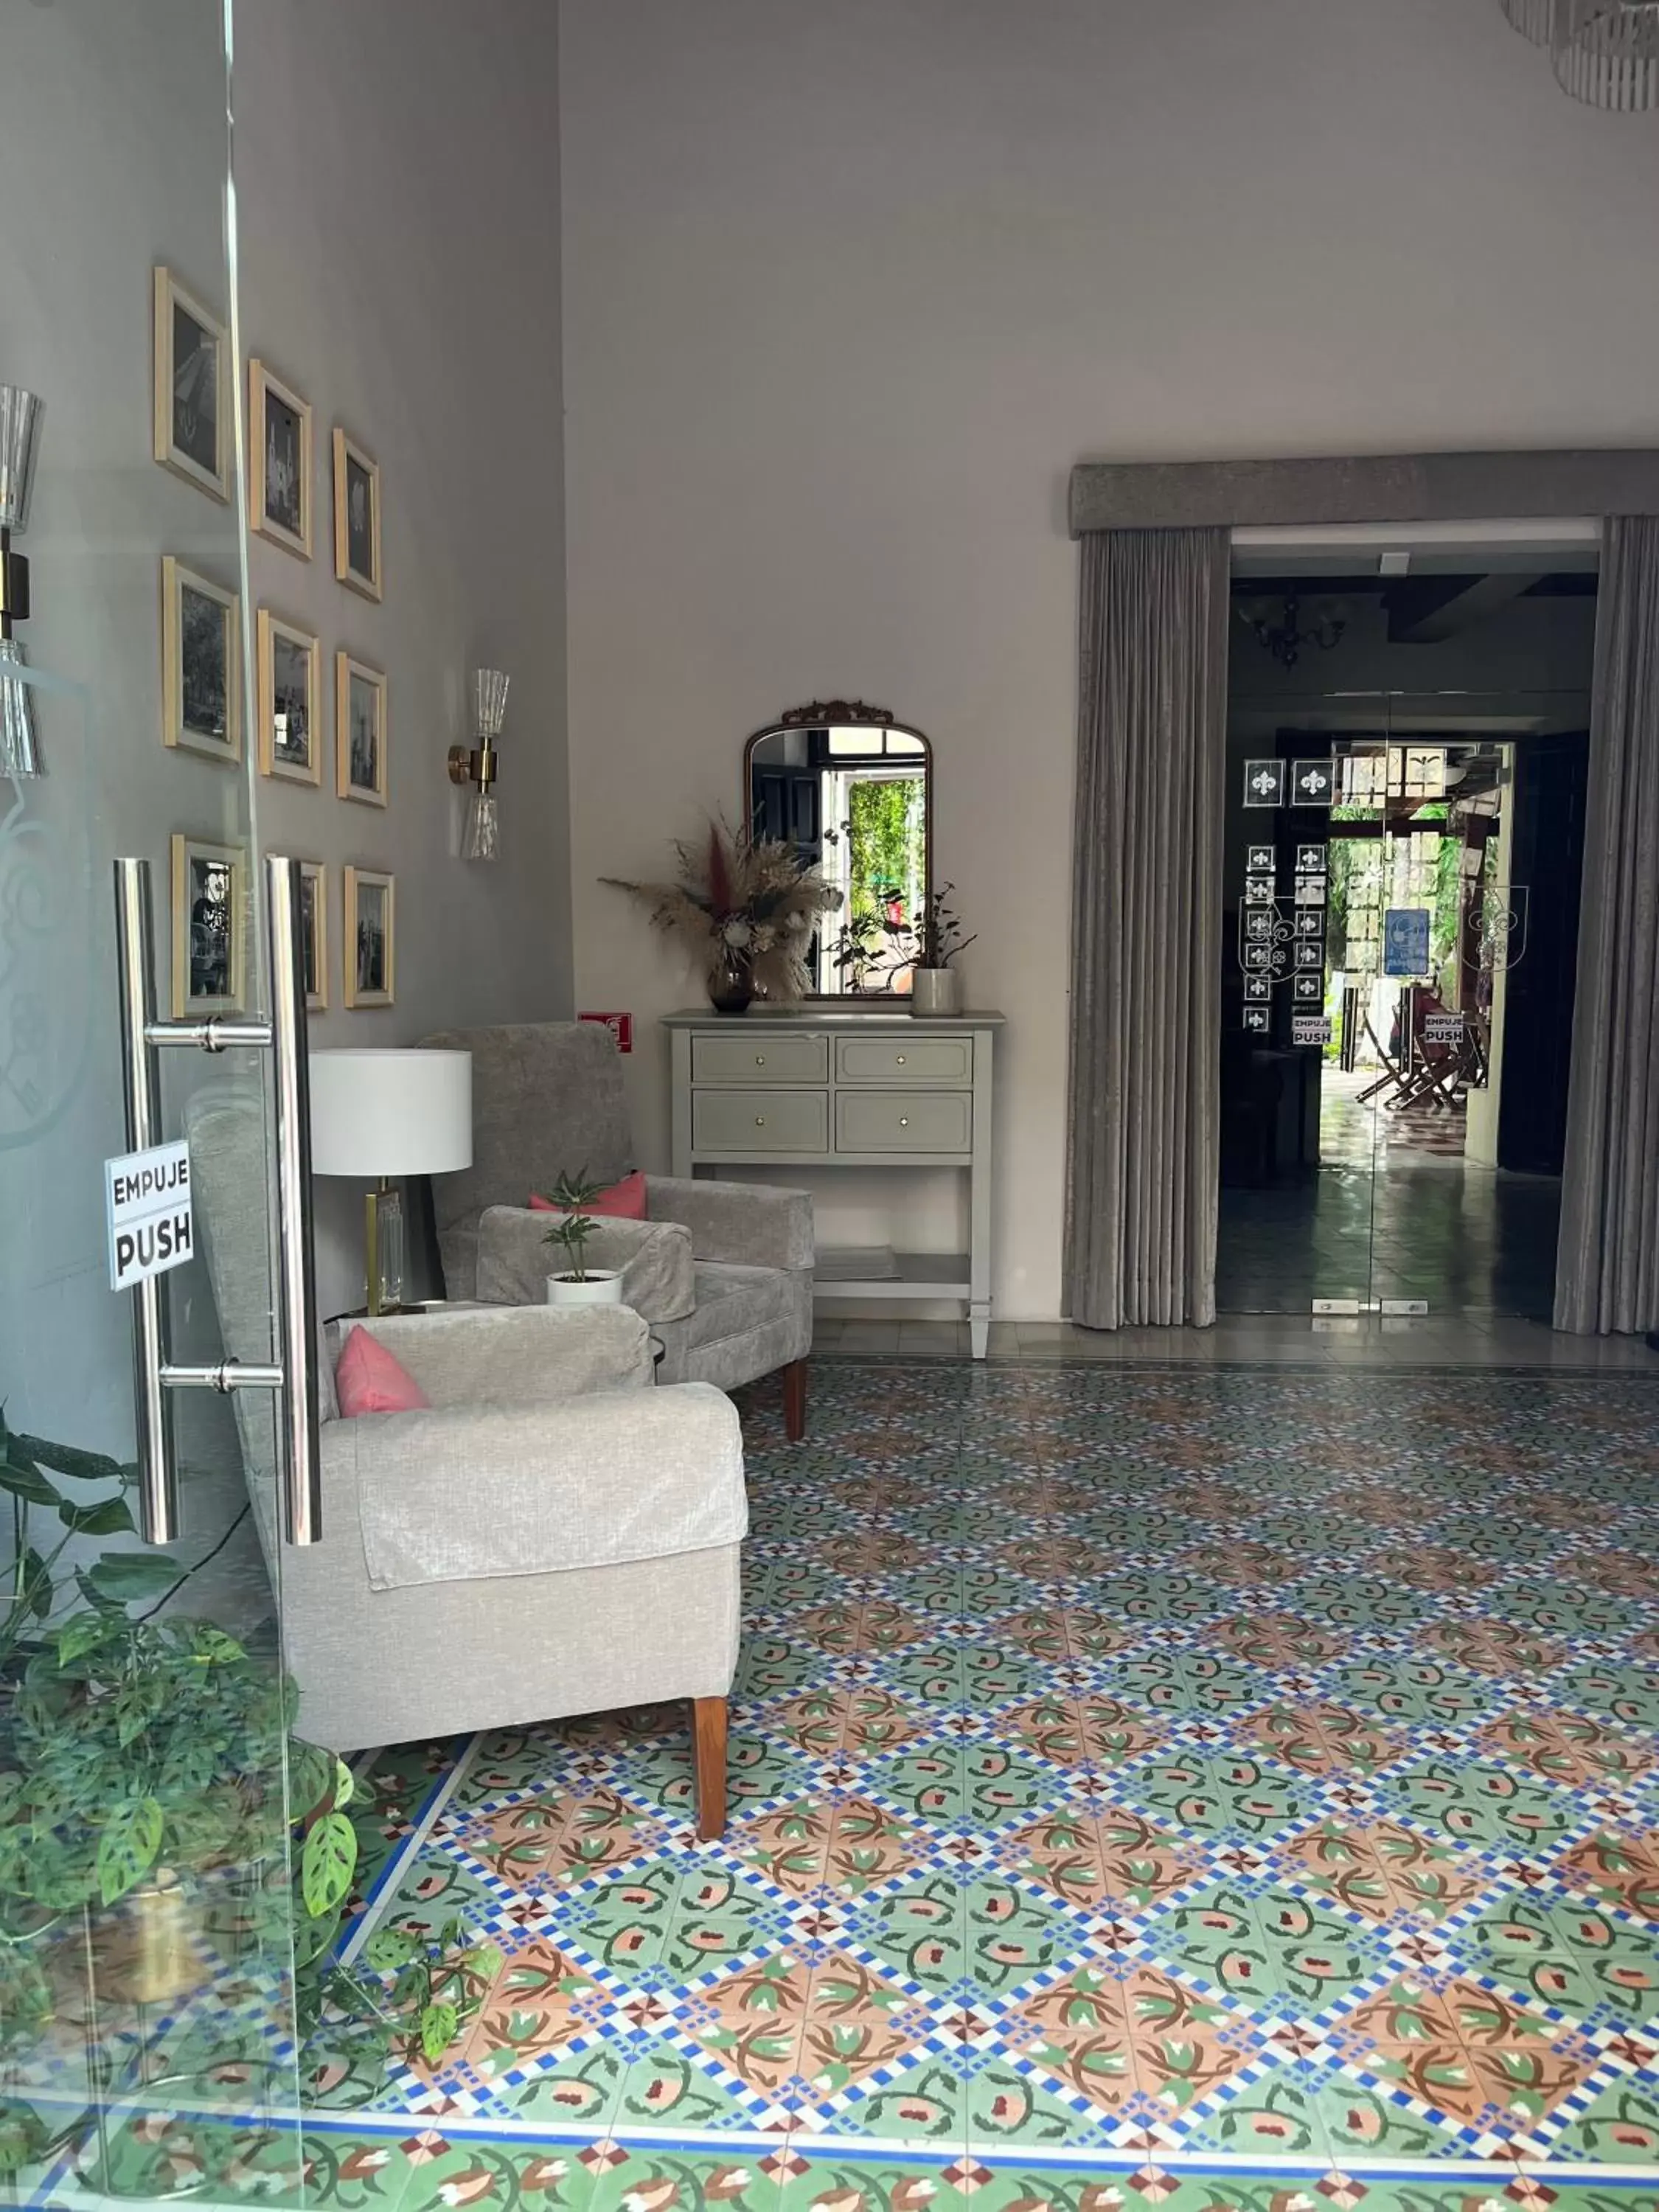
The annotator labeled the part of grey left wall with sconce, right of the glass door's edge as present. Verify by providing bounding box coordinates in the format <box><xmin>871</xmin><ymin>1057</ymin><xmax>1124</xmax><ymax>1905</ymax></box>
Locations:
<box><xmin>234</xmin><ymin>0</ymin><xmax>571</xmax><ymax>1312</ymax></box>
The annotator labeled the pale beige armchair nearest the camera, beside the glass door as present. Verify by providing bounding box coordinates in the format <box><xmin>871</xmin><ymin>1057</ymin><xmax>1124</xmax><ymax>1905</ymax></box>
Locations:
<box><xmin>186</xmin><ymin>1091</ymin><xmax>748</xmax><ymax>1838</ymax></box>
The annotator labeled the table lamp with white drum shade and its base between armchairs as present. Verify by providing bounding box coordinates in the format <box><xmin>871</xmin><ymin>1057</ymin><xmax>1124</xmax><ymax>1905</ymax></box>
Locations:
<box><xmin>312</xmin><ymin>1048</ymin><xmax>473</xmax><ymax>1314</ymax></box>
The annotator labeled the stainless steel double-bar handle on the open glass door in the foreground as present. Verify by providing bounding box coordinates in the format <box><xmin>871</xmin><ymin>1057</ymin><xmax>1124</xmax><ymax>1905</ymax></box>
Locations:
<box><xmin>115</xmin><ymin>854</ymin><xmax>323</xmax><ymax>1544</ymax></box>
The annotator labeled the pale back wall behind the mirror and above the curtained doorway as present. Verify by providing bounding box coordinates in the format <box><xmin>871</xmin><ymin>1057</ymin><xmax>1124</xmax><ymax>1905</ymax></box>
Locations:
<box><xmin>562</xmin><ymin>0</ymin><xmax>1659</xmax><ymax>1316</ymax></box>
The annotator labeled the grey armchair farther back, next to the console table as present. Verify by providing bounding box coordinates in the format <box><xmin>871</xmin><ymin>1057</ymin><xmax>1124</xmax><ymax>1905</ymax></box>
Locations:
<box><xmin>425</xmin><ymin>1022</ymin><xmax>814</xmax><ymax>1442</ymax></box>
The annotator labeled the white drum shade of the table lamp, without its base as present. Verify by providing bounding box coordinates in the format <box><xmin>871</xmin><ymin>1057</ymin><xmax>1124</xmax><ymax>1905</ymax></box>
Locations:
<box><xmin>312</xmin><ymin>1051</ymin><xmax>473</xmax><ymax>1177</ymax></box>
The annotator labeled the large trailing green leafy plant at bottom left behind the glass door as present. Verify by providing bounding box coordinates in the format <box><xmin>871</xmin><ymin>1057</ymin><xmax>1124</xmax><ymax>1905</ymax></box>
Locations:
<box><xmin>0</xmin><ymin>1411</ymin><xmax>489</xmax><ymax>2174</ymax></box>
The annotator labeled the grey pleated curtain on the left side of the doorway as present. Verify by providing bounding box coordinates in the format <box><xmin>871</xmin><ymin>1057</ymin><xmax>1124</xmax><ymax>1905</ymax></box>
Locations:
<box><xmin>1066</xmin><ymin>529</ymin><xmax>1230</xmax><ymax>1329</ymax></box>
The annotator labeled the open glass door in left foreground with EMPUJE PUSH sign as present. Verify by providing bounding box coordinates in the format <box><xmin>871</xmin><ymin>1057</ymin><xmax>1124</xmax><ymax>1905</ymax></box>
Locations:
<box><xmin>0</xmin><ymin>0</ymin><xmax>319</xmax><ymax>2203</ymax></box>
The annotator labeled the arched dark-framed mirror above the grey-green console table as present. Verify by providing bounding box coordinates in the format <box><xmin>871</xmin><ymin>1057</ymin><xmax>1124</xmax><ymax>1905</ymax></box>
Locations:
<box><xmin>743</xmin><ymin>699</ymin><xmax>933</xmax><ymax>1000</ymax></box>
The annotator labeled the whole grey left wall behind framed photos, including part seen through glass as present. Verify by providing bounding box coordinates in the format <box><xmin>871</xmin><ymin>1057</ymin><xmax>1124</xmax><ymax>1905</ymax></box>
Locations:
<box><xmin>0</xmin><ymin>0</ymin><xmax>571</xmax><ymax>1537</ymax></box>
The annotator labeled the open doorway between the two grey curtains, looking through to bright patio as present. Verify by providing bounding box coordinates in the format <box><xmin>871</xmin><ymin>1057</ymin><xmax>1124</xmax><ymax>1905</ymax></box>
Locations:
<box><xmin>1217</xmin><ymin>526</ymin><xmax>1595</xmax><ymax>1321</ymax></box>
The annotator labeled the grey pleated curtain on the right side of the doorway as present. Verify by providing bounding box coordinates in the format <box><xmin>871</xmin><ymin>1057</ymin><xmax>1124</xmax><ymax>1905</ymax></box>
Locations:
<box><xmin>1555</xmin><ymin>515</ymin><xmax>1659</xmax><ymax>1336</ymax></box>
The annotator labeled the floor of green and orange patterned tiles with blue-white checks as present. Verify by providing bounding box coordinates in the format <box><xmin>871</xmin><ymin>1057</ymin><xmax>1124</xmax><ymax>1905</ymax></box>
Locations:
<box><xmin>22</xmin><ymin>1363</ymin><xmax>1659</xmax><ymax>2212</ymax></box>
